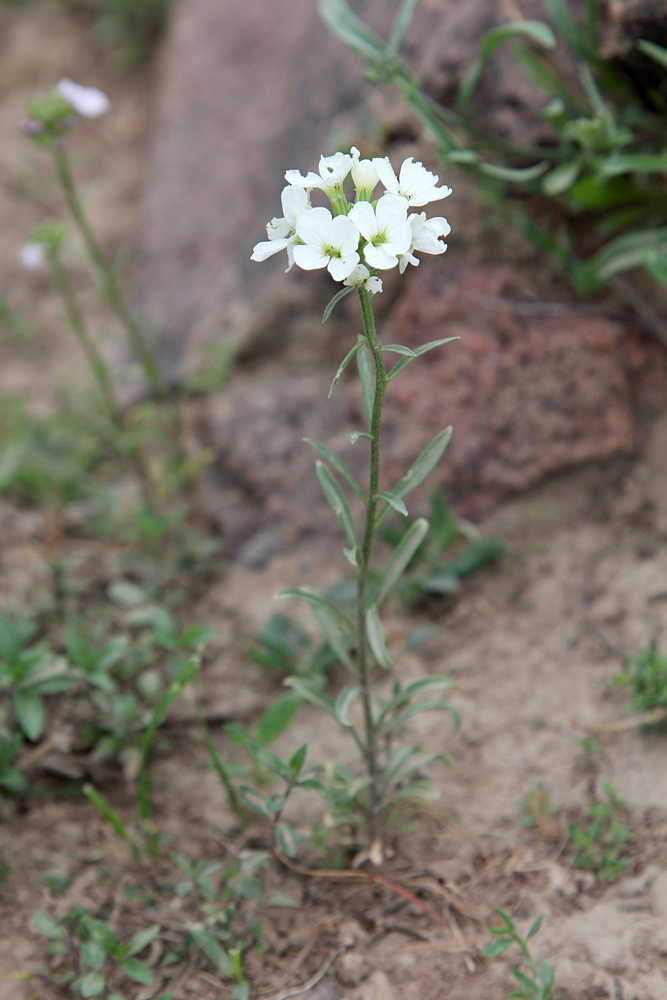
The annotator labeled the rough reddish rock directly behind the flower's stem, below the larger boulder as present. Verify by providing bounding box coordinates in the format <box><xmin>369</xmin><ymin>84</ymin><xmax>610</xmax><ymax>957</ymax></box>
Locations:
<box><xmin>202</xmin><ymin>269</ymin><xmax>634</xmax><ymax>537</ymax></box>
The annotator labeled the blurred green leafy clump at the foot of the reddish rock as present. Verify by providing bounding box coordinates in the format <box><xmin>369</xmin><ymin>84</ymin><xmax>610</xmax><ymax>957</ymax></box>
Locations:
<box><xmin>380</xmin><ymin>491</ymin><xmax>506</xmax><ymax>607</ymax></box>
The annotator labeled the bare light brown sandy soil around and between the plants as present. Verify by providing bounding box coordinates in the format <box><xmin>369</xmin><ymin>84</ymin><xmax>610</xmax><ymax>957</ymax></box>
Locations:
<box><xmin>0</xmin><ymin>6</ymin><xmax>667</xmax><ymax>1000</ymax></box>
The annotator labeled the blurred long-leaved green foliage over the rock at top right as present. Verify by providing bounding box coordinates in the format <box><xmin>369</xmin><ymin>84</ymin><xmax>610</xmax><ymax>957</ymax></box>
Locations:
<box><xmin>319</xmin><ymin>0</ymin><xmax>667</xmax><ymax>294</ymax></box>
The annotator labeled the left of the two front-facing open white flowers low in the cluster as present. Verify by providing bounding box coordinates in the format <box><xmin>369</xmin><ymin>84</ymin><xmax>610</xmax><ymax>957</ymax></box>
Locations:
<box><xmin>292</xmin><ymin>208</ymin><xmax>359</xmax><ymax>281</ymax></box>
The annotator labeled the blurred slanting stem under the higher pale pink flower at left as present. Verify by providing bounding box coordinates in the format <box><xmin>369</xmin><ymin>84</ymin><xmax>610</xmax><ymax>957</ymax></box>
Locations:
<box><xmin>53</xmin><ymin>148</ymin><xmax>181</xmax><ymax>454</ymax></box>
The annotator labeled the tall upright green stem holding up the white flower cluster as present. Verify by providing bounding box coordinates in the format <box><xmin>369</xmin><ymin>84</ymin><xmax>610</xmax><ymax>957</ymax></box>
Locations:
<box><xmin>357</xmin><ymin>288</ymin><xmax>389</xmax><ymax>837</ymax></box>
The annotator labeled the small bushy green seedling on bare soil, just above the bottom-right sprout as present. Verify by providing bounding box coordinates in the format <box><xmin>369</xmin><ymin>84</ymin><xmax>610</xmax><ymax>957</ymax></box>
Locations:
<box><xmin>570</xmin><ymin>781</ymin><xmax>632</xmax><ymax>882</ymax></box>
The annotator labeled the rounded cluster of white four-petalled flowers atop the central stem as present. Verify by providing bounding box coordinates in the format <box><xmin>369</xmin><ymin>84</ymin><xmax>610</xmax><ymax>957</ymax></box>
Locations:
<box><xmin>251</xmin><ymin>147</ymin><xmax>452</xmax><ymax>294</ymax></box>
